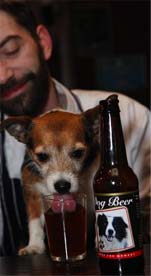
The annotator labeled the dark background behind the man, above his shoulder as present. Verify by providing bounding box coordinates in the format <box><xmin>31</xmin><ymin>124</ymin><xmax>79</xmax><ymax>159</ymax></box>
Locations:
<box><xmin>34</xmin><ymin>0</ymin><xmax>150</xmax><ymax>107</ymax></box>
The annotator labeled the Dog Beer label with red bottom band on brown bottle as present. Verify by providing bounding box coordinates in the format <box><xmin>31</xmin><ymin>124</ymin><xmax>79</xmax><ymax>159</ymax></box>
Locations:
<box><xmin>95</xmin><ymin>191</ymin><xmax>142</xmax><ymax>259</ymax></box>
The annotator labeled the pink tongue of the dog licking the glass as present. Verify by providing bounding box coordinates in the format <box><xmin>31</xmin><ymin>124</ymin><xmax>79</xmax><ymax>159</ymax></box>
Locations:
<box><xmin>51</xmin><ymin>194</ymin><xmax>76</xmax><ymax>213</ymax></box>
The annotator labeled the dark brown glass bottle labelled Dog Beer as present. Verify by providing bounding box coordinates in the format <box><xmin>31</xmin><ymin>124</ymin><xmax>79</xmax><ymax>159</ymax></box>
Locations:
<box><xmin>94</xmin><ymin>95</ymin><xmax>144</xmax><ymax>275</ymax></box>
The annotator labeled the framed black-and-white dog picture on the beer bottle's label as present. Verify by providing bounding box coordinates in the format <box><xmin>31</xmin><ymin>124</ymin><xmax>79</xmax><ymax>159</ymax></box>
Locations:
<box><xmin>97</xmin><ymin>207</ymin><xmax>134</xmax><ymax>252</ymax></box>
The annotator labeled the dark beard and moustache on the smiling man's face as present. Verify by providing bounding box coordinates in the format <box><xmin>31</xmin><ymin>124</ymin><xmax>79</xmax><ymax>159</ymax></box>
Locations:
<box><xmin>0</xmin><ymin>52</ymin><xmax>49</xmax><ymax>117</ymax></box>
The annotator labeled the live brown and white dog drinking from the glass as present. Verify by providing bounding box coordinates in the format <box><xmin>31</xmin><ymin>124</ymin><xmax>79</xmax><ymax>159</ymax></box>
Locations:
<box><xmin>2</xmin><ymin>106</ymin><xmax>99</xmax><ymax>255</ymax></box>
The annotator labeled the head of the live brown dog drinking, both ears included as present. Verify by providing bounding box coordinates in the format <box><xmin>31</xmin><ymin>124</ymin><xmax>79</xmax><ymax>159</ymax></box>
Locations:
<box><xmin>2</xmin><ymin>106</ymin><xmax>99</xmax><ymax>194</ymax></box>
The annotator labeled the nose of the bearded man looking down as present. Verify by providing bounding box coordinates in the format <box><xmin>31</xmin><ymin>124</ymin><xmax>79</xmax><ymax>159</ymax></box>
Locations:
<box><xmin>0</xmin><ymin>60</ymin><xmax>13</xmax><ymax>84</ymax></box>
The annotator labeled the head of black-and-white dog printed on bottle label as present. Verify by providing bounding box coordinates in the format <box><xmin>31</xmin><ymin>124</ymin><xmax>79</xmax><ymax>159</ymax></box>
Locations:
<box><xmin>97</xmin><ymin>214</ymin><xmax>128</xmax><ymax>242</ymax></box>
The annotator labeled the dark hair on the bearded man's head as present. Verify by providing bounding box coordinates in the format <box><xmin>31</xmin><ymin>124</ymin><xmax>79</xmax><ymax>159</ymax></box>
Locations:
<box><xmin>0</xmin><ymin>0</ymin><xmax>38</xmax><ymax>39</ymax></box>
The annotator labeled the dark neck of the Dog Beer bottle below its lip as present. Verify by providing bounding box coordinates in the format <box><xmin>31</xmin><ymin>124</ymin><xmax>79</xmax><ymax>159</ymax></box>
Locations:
<box><xmin>100</xmin><ymin>112</ymin><xmax>128</xmax><ymax>167</ymax></box>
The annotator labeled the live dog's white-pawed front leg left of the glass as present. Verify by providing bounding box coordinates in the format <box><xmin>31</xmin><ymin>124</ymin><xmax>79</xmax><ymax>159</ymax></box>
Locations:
<box><xmin>19</xmin><ymin>193</ymin><xmax>45</xmax><ymax>255</ymax></box>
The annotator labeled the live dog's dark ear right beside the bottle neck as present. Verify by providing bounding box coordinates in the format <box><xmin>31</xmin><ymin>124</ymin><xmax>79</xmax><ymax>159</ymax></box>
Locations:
<box><xmin>83</xmin><ymin>105</ymin><xmax>100</xmax><ymax>141</ymax></box>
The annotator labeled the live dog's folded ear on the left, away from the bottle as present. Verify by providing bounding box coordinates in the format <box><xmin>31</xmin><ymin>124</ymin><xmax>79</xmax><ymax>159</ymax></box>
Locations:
<box><xmin>0</xmin><ymin>116</ymin><xmax>32</xmax><ymax>144</ymax></box>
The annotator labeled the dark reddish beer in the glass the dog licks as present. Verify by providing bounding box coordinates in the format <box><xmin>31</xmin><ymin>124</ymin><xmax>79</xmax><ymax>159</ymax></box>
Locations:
<box><xmin>45</xmin><ymin>194</ymin><xmax>87</xmax><ymax>261</ymax></box>
